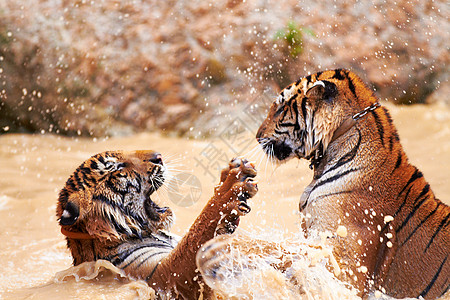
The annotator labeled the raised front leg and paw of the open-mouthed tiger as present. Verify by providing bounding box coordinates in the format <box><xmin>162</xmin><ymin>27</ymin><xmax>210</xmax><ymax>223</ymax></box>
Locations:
<box><xmin>147</xmin><ymin>159</ymin><xmax>258</xmax><ymax>299</ymax></box>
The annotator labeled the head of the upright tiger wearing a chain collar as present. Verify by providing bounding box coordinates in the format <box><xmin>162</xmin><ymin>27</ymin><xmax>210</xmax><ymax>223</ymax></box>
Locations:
<box><xmin>256</xmin><ymin>69</ymin><xmax>376</xmax><ymax>162</ymax></box>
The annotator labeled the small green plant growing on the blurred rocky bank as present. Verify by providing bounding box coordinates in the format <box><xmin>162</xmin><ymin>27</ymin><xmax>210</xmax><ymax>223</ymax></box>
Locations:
<box><xmin>274</xmin><ymin>21</ymin><xmax>316</xmax><ymax>58</ymax></box>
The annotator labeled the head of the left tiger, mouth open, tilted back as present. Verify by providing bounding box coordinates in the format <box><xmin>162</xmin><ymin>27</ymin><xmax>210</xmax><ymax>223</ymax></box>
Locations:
<box><xmin>56</xmin><ymin>151</ymin><xmax>173</xmax><ymax>240</ymax></box>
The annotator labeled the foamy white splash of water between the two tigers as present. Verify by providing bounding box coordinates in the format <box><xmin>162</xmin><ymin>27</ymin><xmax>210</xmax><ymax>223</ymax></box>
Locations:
<box><xmin>198</xmin><ymin>230</ymin><xmax>360</xmax><ymax>299</ymax></box>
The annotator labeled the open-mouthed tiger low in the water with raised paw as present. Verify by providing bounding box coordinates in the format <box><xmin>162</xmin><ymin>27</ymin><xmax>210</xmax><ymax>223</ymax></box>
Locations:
<box><xmin>56</xmin><ymin>150</ymin><xmax>258</xmax><ymax>299</ymax></box>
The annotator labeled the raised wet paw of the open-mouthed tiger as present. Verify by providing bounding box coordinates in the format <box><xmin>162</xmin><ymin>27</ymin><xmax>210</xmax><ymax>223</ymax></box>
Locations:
<box><xmin>215</xmin><ymin>158</ymin><xmax>258</xmax><ymax>234</ymax></box>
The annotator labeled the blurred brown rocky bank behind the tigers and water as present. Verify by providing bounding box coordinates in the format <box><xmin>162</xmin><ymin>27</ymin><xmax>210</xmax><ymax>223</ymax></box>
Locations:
<box><xmin>0</xmin><ymin>0</ymin><xmax>450</xmax><ymax>136</ymax></box>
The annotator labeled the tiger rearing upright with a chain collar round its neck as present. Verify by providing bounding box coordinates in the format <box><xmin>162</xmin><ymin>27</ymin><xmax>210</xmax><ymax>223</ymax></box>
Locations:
<box><xmin>256</xmin><ymin>69</ymin><xmax>450</xmax><ymax>299</ymax></box>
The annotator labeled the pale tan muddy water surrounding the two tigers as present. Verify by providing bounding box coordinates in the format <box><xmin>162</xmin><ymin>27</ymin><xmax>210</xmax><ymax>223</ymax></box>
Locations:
<box><xmin>0</xmin><ymin>106</ymin><xmax>450</xmax><ymax>299</ymax></box>
